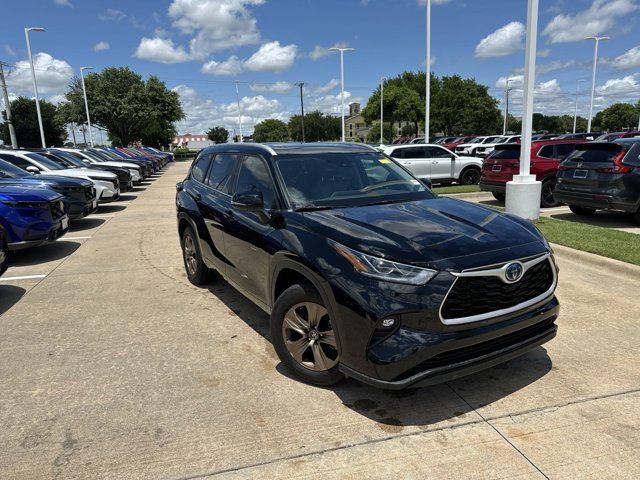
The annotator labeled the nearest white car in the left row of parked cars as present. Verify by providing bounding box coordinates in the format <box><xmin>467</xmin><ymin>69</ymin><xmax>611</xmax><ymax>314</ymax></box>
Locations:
<box><xmin>2</xmin><ymin>150</ymin><xmax>120</xmax><ymax>203</ymax></box>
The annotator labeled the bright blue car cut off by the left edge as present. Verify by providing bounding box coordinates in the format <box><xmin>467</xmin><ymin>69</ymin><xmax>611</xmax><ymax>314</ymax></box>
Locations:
<box><xmin>0</xmin><ymin>185</ymin><xmax>69</xmax><ymax>251</ymax></box>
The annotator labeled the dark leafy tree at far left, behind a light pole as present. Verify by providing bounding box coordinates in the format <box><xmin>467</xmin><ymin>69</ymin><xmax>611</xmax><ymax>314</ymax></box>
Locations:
<box><xmin>0</xmin><ymin>97</ymin><xmax>67</xmax><ymax>148</ymax></box>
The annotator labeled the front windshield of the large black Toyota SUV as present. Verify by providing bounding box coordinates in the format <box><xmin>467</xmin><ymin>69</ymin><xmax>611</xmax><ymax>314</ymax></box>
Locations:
<box><xmin>276</xmin><ymin>152</ymin><xmax>434</xmax><ymax>208</ymax></box>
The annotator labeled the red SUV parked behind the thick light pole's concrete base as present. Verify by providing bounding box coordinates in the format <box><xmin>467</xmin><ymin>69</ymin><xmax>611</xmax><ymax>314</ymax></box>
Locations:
<box><xmin>480</xmin><ymin>139</ymin><xmax>587</xmax><ymax>207</ymax></box>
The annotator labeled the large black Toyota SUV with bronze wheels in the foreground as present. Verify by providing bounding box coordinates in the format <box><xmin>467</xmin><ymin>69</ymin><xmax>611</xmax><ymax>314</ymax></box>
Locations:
<box><xmin>176</xmin><ymin>143</ymin><xmax>559</xmax><ymax>389</ymax></box>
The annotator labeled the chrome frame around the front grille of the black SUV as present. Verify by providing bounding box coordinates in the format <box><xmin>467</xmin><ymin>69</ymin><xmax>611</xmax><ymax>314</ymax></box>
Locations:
<box><xmin>438</xmin><ymin>253</ymin><xmax>558</xmax><ymax>325</ymax></box>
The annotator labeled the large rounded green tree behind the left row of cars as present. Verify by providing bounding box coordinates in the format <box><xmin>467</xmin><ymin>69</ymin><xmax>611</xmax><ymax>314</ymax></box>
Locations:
<box><xmin>65</xmin><ymin>67</ymin><xmax>184</xmax><ymax>146</ymax></box>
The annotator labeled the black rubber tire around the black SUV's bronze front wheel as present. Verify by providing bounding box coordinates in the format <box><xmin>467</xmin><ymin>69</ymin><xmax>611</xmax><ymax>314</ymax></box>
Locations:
<box><xmin>270</xmin><ymin>283</ymin><xmax>344</xmax><ymax>387</ymax></box>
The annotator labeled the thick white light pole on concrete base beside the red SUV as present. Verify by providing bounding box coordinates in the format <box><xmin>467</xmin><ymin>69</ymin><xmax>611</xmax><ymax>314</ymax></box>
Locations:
<box><xmin>505</xmin><ymin>0</ymin><xmax>542</xmax><ymax>220</ymax></box>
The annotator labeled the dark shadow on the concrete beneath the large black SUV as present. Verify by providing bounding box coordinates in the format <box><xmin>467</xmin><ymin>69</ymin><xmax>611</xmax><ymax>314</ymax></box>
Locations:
<box><xmin>204</xmin><ymin>277</ymin><xmax>552</xmax><ymax>433</ymax></box>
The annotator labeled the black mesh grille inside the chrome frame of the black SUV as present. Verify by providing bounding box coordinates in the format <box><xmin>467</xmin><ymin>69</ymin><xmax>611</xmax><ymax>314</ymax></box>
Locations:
<box><xmin>441</xmin><ymin>260</ymin><xmax>554</xmax><ymax>319</ymax></box>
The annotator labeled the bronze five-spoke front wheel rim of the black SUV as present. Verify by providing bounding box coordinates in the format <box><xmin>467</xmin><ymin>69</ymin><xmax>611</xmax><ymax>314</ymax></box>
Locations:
<box><xmin>282</xmin><ymin>302</ymin><xmax>338</xmax><ymax>372</ymax></box>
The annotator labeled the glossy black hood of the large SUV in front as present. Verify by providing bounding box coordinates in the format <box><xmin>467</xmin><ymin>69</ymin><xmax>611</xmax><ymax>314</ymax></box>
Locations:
<box><xmin>304</xmin><ymin>197</ymin><xmax>546</xmax><ymax>269</ymax></box>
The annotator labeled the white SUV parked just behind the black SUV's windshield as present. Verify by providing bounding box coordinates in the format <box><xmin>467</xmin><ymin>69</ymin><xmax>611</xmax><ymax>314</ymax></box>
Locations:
<box><xmin>382</xmin><ymin>144</ymin><xmax>482</xmax><ymax>185</ymax></box>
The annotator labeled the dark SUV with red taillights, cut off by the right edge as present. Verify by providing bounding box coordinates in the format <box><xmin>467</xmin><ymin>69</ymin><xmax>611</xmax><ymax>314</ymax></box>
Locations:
<box><xmin>554</xmin><ymin>138</ymin><xmax>640</xmax><ymax>223</ymax></box>
